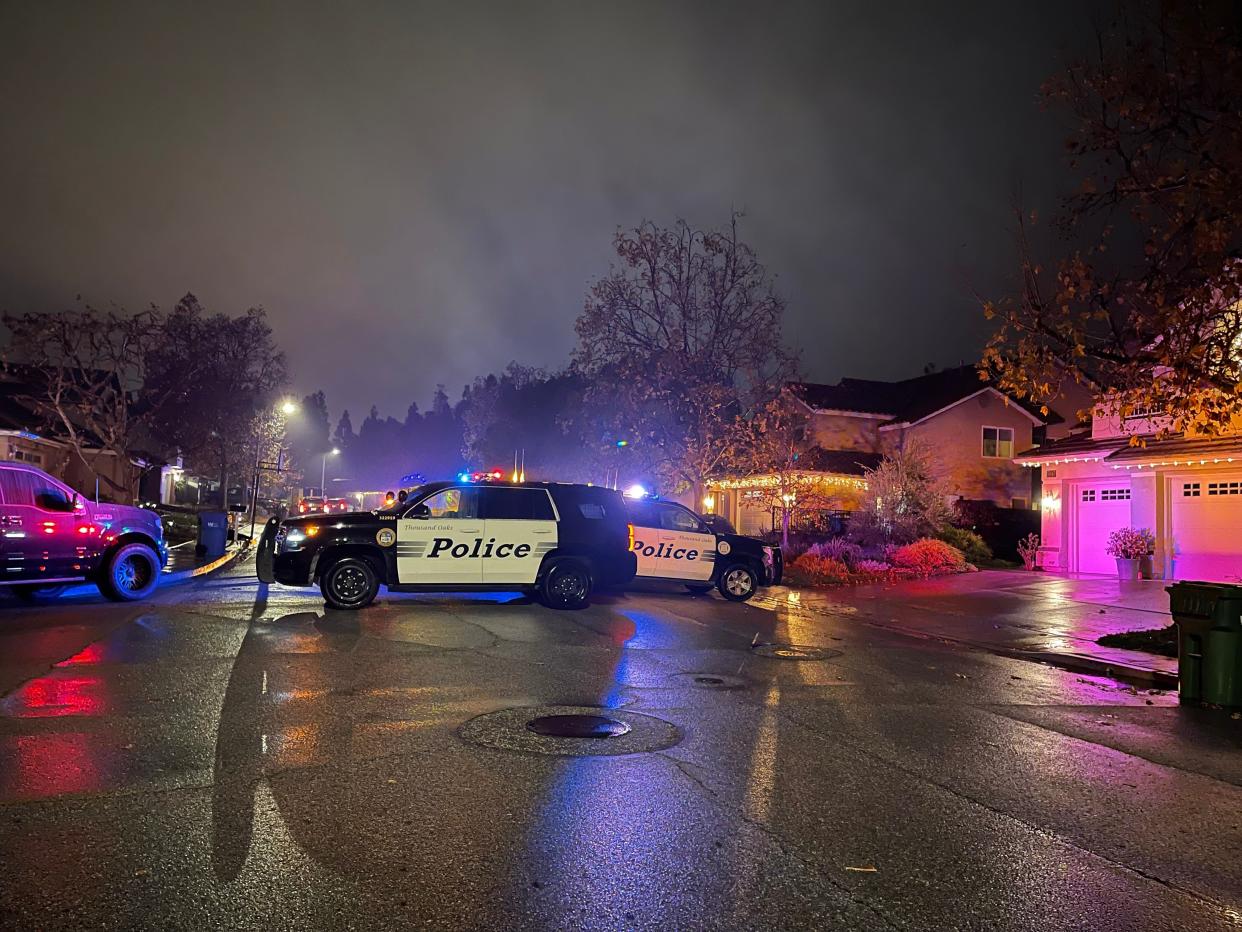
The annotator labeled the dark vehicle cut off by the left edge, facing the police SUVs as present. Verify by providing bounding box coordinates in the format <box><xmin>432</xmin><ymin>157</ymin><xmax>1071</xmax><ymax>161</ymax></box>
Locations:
<box><xmin>0</xmin><ymin>461</ymin><xmax>168</xmax><ymax>601</ymax></box>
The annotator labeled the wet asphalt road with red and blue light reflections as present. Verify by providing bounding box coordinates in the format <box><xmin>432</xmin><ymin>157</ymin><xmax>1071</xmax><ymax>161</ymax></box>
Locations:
<box><xmin>0</xmin><ymin>559</ymin><xmax>1242</xmax><ymax>930</ymax></box>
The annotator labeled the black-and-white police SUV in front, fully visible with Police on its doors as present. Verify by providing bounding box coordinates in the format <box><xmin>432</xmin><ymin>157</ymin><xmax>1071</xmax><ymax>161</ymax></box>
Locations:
<box><xmin>256</xmin><ymin>482</ymin><xmax>636</xmax><ymax>609</ymax></box>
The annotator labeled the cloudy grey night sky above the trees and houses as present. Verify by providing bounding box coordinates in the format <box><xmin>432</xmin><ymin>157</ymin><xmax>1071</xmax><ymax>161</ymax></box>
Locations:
<box><xmin>7</xmin><ymin>0</ymin><xmax>1090</xmax><ymax>415</ymax></box>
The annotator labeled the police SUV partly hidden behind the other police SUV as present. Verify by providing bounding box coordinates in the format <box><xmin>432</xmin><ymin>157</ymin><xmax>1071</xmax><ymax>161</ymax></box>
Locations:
<box><xmin>626</xmin><ymin>498</ymin><xmax>784</xmax><ymax>601</ymax></box>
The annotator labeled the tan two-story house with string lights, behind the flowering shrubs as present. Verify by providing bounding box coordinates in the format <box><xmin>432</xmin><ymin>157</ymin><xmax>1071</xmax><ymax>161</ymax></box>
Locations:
<box><xmin>704</xmin><ymin>365</ymin><xmax>1063</xmax><ymax>533</ymax></box>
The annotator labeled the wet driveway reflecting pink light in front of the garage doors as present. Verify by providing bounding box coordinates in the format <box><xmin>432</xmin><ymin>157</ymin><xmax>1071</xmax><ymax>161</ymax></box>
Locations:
<box><xmin>755</xmin><ymin>570</ymin><xmax>1177</xmax><ymax>688</ymax></box>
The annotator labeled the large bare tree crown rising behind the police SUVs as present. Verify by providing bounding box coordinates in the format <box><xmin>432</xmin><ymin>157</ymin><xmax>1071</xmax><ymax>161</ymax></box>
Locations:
<box><xmin>574</xmin><ymin>215</ymin><xmax>794</xmax><ymax>491</ymax></box>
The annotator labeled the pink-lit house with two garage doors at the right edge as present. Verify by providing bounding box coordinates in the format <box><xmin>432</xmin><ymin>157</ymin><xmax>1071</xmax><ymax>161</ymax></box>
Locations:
<box><xmin>1017</xmin><ymin>405</ymin><xmax>1242</xmax><ymax>582</ymax></box>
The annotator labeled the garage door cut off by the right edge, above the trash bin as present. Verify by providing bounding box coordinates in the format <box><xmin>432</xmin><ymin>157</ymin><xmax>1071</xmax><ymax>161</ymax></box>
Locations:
<box><xmin>1170</xmin><ymin>473</ymin><xmax>1242</xmax><ymax>583</ymax></box>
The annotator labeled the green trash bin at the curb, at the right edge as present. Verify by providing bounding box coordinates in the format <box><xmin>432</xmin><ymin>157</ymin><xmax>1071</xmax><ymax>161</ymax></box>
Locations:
<box><xmin>1167</xmin><ymin>582</ymin><xmax>1242</xmax><ymax>708</ymax></box>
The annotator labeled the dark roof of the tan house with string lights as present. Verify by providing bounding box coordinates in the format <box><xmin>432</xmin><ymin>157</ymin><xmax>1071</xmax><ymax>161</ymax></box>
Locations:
<box><xmin>786</xmin><ymin>365</ymin><xmax>1063</xmax><ymax>424</ymax></box>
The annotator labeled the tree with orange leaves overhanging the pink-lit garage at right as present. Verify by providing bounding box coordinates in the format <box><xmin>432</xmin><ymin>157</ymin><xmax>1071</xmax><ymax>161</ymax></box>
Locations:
<box><xmin>981</xmin><ymin>2</ymin><xmax>1242</xmax><ymax>434</ymax></box>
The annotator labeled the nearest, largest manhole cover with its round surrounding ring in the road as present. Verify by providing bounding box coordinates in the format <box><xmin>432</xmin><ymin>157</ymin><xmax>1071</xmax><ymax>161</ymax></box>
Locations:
<box><xmin>458</xmin><ymin>706</ymin><xmax>682</xmax><ymax>757</ymax></box>
